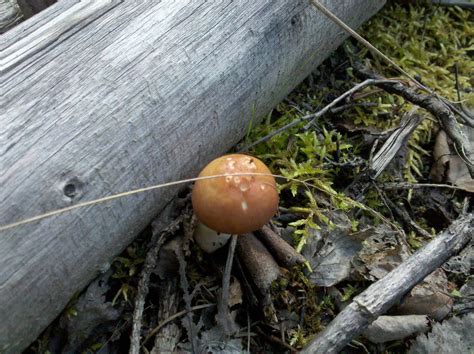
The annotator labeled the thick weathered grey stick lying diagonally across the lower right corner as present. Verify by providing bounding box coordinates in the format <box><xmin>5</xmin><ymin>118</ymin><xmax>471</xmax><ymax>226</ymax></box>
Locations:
<box><xmin>302</xmin><ymin>213</ymin><xmax>474</xmax><ymax>353</ymax></box>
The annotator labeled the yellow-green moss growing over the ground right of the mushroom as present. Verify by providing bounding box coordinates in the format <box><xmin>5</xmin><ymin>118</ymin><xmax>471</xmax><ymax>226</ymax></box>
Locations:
<box><xmin>246</xmin><ymin>4</ymin><xmax>474</xmax><ymax>347</ymax></box>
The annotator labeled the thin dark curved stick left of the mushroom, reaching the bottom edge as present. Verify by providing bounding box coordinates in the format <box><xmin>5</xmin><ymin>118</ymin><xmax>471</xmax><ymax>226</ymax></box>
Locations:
<box><xmin>129</xmin><ymin>217</ymin><xmax>182</xmax><ymax>354</ymax></box>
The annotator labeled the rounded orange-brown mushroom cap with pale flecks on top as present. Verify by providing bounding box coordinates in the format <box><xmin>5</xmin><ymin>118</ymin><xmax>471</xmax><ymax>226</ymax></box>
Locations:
<box><xmin>192</xmin><ymin>154</ymin><xmax>278</xmax><ymax>235</ymax></box>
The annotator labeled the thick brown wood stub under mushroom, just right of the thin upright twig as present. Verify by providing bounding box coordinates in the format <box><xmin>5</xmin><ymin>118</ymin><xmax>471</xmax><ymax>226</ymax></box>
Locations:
<box><xmin>237</xmin><ymin>234</ymin><xmax>281</xmax><ymax>295</ymax></box>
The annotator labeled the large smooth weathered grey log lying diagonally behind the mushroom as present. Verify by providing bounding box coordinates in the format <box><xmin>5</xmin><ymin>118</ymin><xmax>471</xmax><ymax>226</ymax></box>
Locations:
<box><xmin>0</xmin><ymin>0</ymin><xmax>384</xmax><ymax>352</ymax></box>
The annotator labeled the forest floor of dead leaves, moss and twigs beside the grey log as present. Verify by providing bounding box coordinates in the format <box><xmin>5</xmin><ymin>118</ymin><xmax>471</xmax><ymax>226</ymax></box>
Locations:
<box><xmin>27</xmin><ymin>2</ymin><xmax>474</xmax><ymax>353</ymax></box>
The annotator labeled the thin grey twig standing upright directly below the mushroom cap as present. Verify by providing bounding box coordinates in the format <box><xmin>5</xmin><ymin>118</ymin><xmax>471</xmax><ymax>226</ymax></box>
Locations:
<box><xmin>217</xmin><ymin>235</ymin><xmax>239</xmax><ymax>336</ymax></box>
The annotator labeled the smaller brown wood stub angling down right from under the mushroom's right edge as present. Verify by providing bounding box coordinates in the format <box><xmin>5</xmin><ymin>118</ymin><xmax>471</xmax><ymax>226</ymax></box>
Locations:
<box><xmin>256</xmin><ymin>225</ymin><xmax>306</xmax><ymax>268</ymax></box>
